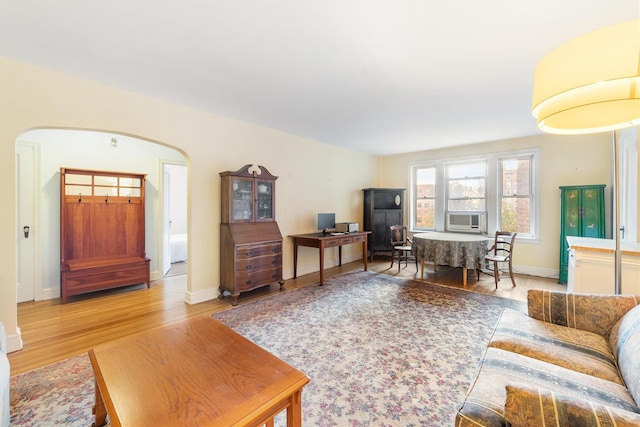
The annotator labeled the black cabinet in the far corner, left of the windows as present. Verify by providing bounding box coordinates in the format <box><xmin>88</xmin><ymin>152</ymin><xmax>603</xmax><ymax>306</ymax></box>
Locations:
<box><xmin>362</xmin><ymin>188</ymin><xmax>404</xmax><ymax>260</ymax></box>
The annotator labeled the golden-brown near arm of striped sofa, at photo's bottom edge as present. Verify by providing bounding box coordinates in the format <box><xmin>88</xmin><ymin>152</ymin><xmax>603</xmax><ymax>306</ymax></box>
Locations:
<box><xmin>504</xmin><ymin>384</ymin><xmax>640</xmax><ymax>427</ymax></box>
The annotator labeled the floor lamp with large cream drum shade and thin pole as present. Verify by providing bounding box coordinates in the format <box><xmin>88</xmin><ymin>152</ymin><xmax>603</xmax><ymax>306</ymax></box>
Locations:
<box><xmin>532</xmin><ymin>19</ymin><xmax>640</xmax><ymax>294</ymax></box>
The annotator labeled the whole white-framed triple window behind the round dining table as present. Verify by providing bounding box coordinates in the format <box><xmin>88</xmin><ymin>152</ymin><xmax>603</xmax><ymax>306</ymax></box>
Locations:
<box><xmin>409</xmin><ymin>150</ymin><xmax>539</xmax><ymax>239</ymax></box>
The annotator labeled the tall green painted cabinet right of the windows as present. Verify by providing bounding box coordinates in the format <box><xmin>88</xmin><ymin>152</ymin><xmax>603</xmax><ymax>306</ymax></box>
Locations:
<box><xmin>558</xmin><ymin>184</ymin><xmax>605</xmax><ymax>283</ymax></box>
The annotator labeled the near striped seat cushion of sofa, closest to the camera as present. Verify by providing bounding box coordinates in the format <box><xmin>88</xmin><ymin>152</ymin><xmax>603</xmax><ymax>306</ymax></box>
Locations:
<box><xmin>456</xmin><ymin>347</ymin><xmax>640</xmax><ymax>427</ymax></box>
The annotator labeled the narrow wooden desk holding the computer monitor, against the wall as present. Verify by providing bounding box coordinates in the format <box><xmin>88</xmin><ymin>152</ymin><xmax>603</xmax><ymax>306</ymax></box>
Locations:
<box><xmin>289</xmin><ymin>231</ymin><xmax>371</xmax><ymax>286</ymax></box>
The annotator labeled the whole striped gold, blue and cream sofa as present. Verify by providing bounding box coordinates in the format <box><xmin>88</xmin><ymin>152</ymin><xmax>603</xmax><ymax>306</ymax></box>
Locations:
<box><xmin>455</xmin><ymin>290</ymin><xmax>640</xmax><ymax>427</ymax></box>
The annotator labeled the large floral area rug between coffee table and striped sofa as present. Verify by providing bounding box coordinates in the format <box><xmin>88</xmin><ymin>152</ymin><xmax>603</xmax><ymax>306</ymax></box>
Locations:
<box><xmin>214</xmin><ymin>272</ymin><xmax>525</xmax><ymax>427</ymax></box>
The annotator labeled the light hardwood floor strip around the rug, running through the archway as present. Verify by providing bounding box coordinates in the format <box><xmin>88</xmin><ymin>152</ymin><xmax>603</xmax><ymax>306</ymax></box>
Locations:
<box><xmin>9</xmin><ymin>257</ymin><xmax>566</xmax><ymax>375</ymax></box>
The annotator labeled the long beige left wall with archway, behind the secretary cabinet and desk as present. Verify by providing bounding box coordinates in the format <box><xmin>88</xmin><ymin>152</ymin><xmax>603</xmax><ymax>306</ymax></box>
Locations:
<box><xmin>0</xmin><ymin>58</ymin><xmax>378</xmax><ymax>349</ymax></box>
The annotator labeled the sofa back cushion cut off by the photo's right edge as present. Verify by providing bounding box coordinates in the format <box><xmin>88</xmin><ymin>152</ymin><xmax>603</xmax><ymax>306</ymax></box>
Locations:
<box><xmin>610</xmin><ymin>306</ymin><xmax>640</xmax><ymax>404</ymax></box>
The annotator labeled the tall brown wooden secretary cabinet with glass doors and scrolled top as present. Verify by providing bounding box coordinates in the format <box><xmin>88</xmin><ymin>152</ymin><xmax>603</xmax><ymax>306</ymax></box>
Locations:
<box><xmin>219</xmin><ymin>165</ymin><xmax>284</xmax><ymax>305</ymax></box>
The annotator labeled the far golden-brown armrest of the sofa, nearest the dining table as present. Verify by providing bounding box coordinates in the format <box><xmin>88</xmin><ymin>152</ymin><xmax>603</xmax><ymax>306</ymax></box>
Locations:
<box><xmin>527</xmin><ymin>289</ymin><xmax>640</xmax><ymax>339</ymax></box>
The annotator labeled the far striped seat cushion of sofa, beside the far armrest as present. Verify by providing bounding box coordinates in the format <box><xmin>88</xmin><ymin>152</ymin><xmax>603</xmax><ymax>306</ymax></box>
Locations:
<box><xmin>489</xmin><ymin>309</ymin><xmax>624</xmax><ymax>385</ymax></box>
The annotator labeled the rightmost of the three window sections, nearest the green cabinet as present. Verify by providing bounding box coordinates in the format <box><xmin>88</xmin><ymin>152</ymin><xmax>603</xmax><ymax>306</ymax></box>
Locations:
<box><xmin>498</xmin><ymin>155</ymin><xmax>533</xmax><ymax>235</ymax></box>
